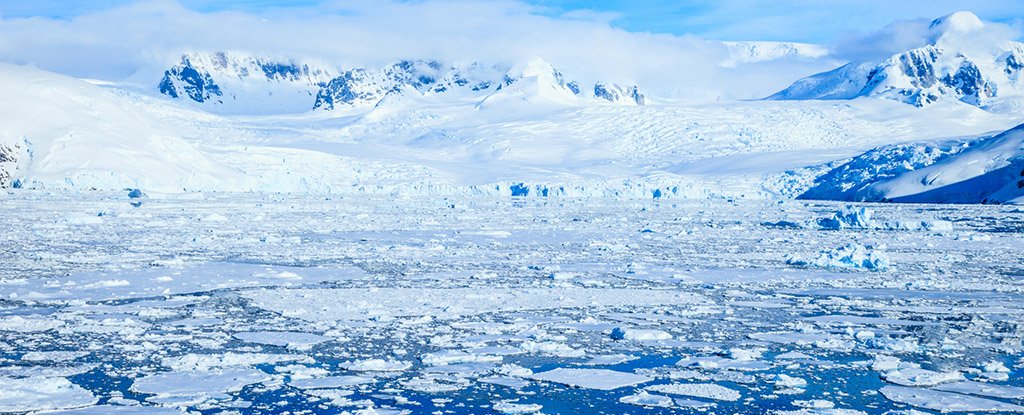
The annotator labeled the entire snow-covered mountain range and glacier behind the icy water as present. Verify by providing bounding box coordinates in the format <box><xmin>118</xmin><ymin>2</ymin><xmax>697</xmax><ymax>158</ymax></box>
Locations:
<box><xmin>0</xmin><ymin>9</ymin><xmax>1024</xmax><ymax>203</ymax></box>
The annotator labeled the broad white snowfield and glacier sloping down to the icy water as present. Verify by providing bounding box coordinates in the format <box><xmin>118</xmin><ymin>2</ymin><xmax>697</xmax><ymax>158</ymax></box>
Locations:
<box><xmin>0</xmin><ymin>55</ymin><xmax>1022</xmax><ymax>201</ymax></box>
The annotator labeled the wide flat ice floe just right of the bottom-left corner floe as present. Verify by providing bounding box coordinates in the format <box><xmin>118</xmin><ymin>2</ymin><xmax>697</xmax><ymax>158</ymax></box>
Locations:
<box><xmin>131</xmin><ymin>369</ymin><xmax>271</xmax><ymax>403</ymax></box>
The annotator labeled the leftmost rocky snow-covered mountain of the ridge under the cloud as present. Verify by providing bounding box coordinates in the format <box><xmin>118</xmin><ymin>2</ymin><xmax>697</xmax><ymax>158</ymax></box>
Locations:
<box><xmin>159</xmin><ymin>52</ymin><xmax>338</xmax><ymax>114</ymax></box>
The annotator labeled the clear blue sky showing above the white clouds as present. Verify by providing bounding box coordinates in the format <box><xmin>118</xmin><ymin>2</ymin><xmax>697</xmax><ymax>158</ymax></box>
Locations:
<box><xmin>0</xmin><ymin>0</ymin><xmax>1024</xmax><ymax>43</ymax></box>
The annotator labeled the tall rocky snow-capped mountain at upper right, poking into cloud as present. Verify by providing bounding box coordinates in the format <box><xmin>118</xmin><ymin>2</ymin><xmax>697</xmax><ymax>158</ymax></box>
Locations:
<box><xmin>769</xmin><ymin>11</ymin><xmax>1024</xmax><ymax>107</ymax></box>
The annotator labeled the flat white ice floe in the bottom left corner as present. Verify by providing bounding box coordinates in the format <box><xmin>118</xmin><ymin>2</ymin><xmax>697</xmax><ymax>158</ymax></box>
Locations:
<box><xmin>0</xmin><ymin>377</ymin><xmax>97</xmax><ymax>413</ymax></box>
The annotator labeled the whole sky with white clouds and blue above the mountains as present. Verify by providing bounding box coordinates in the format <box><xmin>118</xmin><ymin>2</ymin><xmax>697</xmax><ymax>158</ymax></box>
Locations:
<box><xmin>0</xmin><ymin>0</ymin><xmax>1024</xmax><ymax>97</ymax></box>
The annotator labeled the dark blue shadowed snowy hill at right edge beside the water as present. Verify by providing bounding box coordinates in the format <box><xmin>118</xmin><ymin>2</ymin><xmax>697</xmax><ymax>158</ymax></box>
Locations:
<box><xmin>801</xmin><ymin>125</ymin><xmax>1024</xmax><ymax>203</ymax></box>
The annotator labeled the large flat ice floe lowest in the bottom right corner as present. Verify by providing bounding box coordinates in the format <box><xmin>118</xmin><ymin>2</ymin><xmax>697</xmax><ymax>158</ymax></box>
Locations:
<box><xmin>881</xmin><ymin>386</ymin><xmax>1024</xmax><ymax>412</ymax></box>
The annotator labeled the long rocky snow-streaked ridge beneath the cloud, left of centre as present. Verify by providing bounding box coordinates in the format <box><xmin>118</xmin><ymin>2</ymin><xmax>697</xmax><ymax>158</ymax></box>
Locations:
<box><xmin>159</xmin><ymin>52</ymin><xmax>647</xmax><ymax>115</ymax></box>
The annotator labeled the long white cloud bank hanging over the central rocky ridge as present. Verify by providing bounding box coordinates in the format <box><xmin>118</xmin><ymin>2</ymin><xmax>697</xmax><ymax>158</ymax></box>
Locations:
<box><xmin>0</xmin><ymin>0</ymin><xmax>847</xmax><ymax>97</ymax></box>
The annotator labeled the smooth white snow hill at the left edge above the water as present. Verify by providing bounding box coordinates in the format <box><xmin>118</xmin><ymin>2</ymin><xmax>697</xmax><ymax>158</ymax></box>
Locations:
<box><xmin>0</xmin><ymin>65</ymin><xmax>234</xmax><ymax>191</ymax></box>
